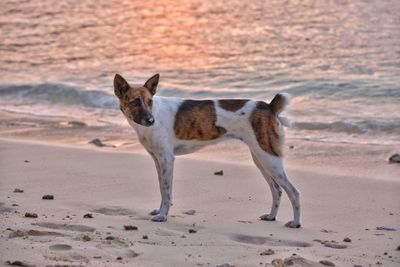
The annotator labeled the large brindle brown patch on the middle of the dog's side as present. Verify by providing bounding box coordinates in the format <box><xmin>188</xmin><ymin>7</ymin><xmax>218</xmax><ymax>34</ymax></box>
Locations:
<box><xmin>174</xmin><ymin>100</ymin><xmax>226</xmax><ymax>141</ymax></box>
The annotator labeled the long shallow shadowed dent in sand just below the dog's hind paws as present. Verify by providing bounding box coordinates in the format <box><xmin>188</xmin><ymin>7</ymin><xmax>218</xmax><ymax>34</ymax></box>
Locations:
<box><xmin>230</xmin><ymin>234</ymin><xmax>312</xmax><ymax>247</ymax></box>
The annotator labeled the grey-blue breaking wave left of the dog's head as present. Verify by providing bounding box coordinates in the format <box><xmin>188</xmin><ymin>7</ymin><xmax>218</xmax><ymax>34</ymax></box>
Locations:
<box><xmin>0</xmin><ymin>83</ymin><xmax>118</xmax><ymax>109</ymax></box>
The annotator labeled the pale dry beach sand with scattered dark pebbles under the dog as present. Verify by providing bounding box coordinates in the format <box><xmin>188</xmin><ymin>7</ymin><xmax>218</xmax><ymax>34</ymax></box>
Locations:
<box><xmin>0</xmin><ymin>139</ymin><xmax>400</xmax><ymax>266</ymax></box>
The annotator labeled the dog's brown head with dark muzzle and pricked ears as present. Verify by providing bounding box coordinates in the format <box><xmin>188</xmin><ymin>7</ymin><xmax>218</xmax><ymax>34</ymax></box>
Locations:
<box><xmin>114</xmin><ymin>74</ymin><xmax>160</xmax><ymax>127</ymax></box>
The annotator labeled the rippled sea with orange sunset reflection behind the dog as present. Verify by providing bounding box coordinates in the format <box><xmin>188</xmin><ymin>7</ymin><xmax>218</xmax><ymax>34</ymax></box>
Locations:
<box><xmin>0</xmin><ymin>0</ymin><xmax>400</xmax><ymax>145</ymax></box>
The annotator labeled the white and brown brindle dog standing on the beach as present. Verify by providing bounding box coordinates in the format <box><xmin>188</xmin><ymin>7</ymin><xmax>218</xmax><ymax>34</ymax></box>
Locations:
<box><xmin>114</xmin><ymin>74</ymin><xmax>300</xmax><ymax>228</ymax></box>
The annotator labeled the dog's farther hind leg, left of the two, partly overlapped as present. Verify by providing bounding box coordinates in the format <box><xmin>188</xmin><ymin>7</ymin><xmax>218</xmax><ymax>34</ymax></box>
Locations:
<box><xmin>251</xmin><ymin>153</ymin><xmax>282</xmax><ymax>221</ymax></box>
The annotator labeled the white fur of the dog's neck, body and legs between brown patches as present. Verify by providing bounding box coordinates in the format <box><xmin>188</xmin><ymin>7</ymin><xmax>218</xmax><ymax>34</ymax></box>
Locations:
<box><xmin>128</xmin><ymin>95</ymin><xmax>300</xmax><ymax>227</ymax></box>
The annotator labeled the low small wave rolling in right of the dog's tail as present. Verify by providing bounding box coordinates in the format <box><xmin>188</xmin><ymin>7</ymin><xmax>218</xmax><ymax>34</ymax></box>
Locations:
<box><xmin>292</xmin><ymin>119</ymin><xmax>400</xmax><ymax>135</ymax></box>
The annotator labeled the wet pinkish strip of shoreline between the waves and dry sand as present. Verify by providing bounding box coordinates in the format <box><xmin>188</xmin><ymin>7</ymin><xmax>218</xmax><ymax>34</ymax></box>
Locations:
<box><xmin>0</xmin><ymin>104</ymin><xmax>400</xmax><ymax>184</ymax></box>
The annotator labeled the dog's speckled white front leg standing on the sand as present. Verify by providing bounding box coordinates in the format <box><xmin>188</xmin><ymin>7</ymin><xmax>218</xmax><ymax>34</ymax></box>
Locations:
<box><xmin>151</xmin><ymin>154</ymin><xmax>175</xmax><ymax>222</ymax></box>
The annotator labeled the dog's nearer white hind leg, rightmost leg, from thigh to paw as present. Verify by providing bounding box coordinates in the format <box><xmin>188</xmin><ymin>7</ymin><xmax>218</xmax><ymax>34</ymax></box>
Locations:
<box><xmin>256</xmin><ymin>151</ymin><xmax>300</xmax><ymax>228</ymax></box>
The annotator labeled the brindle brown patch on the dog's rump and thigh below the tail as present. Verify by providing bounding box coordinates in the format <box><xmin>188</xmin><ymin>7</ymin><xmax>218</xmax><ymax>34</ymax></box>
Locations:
<box><xmin>249</xmin><ymin>101</ymin><xmax>284</xmax><ymax>157</ymax></box>
